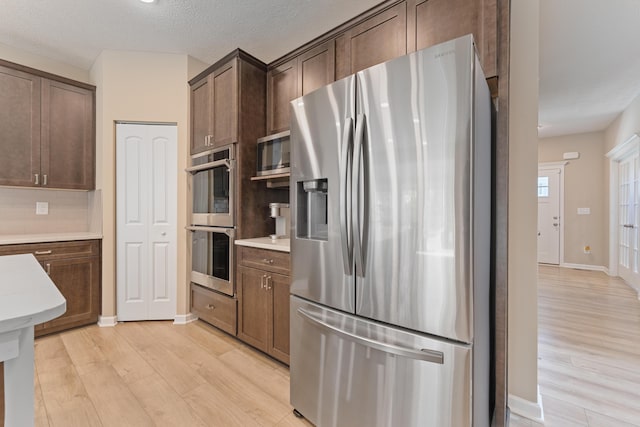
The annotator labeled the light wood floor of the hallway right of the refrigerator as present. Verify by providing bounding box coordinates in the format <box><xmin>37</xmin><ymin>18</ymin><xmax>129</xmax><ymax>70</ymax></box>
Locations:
<box><xmin>511</xmin><ymin>266</ymin><xmax>640</xmax><ymax>427</ymax></box>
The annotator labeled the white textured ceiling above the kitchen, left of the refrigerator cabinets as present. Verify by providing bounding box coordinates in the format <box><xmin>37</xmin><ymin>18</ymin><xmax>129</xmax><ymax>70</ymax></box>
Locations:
<box><xmin>0</xmin><ymin>0</ymin><xmax>381</xmax><ymax>69</ymax></box>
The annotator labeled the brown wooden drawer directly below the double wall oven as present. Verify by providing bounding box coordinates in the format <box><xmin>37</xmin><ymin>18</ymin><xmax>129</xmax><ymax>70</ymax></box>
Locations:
<box><xmin>191</xmin><ymin>283</ymin><xmax>237</xmax><ymax>335</ymax></box>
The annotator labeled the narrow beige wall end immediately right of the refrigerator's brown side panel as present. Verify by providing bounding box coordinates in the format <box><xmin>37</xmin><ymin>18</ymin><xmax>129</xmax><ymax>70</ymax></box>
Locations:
<box><xmin>508</xmin><ymin>0</ymin><xmax>539</xmax><ymax>412</ymax></box>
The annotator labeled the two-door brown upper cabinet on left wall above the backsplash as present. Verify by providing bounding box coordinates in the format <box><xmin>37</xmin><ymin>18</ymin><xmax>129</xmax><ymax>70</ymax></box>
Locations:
<box><xmin>0</xmin><ymin>62</ymin><xmax>95</xmax><ymax>190</ymax></box>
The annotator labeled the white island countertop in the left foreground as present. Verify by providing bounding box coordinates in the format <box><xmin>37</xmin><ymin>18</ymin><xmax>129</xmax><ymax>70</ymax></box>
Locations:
<box><xmin>0</xmin><ymin>254</ymin><xmax>67</xmax><ymax>333</ymax></box>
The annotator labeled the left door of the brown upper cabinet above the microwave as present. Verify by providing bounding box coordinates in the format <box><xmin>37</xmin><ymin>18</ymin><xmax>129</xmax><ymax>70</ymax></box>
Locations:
<box><xmin>267</xmin><ymin>58</ymin><xmax>299</xmax><ymax>134</ymax></box>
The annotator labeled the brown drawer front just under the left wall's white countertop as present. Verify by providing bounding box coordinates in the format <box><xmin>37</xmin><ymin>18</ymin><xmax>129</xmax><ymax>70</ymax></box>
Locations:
<box><xmin>0</xmin><ymin>240</ymin><xmax>100</xmax><ymax>261</ymax></box>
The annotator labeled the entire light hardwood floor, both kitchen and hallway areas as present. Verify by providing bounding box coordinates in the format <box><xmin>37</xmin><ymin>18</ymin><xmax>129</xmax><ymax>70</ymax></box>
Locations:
<box><xmin>30</xmin><ymin>266</ymin><xmax>640</xmax><ymax>427</ymax></box>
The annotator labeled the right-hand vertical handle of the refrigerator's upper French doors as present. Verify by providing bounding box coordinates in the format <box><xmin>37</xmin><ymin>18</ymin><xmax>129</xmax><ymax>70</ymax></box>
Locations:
<box><xmin>351</xmin><ymin>114</ymin><xmax>366</xmax><ymax>277</ymax></box>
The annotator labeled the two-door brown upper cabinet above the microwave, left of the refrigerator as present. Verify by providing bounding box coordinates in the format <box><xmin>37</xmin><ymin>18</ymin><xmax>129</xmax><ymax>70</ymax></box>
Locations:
<box><xmin>267</xmin><ymin>40</ymin><xmax>335</xmax><ymax>135</ymax></box>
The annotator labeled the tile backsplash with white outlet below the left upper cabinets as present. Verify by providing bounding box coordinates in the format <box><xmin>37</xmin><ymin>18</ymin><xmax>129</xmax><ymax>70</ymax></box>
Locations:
<box><xmin>0</xmin><ymin>187</ymin><xmax>96</xmax><ymax>235</ymax></box>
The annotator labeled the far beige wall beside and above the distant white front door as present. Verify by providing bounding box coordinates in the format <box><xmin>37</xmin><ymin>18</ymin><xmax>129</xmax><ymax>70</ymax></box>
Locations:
<box><xmin>538</xmin><ymin>132</ymin><xmax>609</xmax><ymax>267</ymax></box>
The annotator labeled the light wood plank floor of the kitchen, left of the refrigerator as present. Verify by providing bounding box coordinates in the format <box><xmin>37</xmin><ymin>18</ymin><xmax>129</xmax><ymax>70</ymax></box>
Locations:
<box><xmin>35</xmin><ymin>322</ymin><xmax>310</xmax><ymax>427</ymax></box>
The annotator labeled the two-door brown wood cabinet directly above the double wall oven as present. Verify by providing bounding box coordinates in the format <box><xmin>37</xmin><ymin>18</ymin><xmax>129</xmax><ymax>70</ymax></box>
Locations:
<box><xmin>191</xmin><ymin>58</ymin><xmax>238</xmax><ymax>154</ymax></box>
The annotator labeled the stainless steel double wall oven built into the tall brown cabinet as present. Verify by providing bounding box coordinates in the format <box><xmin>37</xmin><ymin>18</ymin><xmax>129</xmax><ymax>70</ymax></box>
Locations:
<box><xmin>187</xmin><ymin>144</ymin><xmax>236</xmax><ymax>295</ymax></box>
